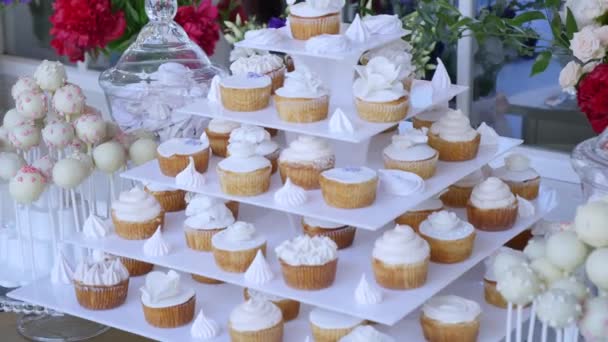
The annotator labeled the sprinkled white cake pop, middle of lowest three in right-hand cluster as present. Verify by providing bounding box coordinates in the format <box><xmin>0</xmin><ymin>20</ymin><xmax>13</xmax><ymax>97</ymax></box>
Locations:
<box><xmin>536</xmin><ymin>289</ymin><xmax>583</xmax><ymax>329</ymax></box>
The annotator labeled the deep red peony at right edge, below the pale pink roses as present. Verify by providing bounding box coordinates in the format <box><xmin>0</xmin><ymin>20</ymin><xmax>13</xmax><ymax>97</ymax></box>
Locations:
<box><xmin>577</xmin><ymin>64</ymin><xmax>608</xmax><ymax>134</ymax></box>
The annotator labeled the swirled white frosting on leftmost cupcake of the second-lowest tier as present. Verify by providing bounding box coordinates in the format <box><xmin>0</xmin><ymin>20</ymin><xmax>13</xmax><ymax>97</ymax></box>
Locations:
<box><xmin>112</xmin><ymin>187</ymin><xmax>162</xmax><ymax>222</ymax></box>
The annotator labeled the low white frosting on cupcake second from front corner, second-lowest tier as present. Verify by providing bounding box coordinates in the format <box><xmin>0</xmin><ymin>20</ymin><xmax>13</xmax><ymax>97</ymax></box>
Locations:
<box><xmin>420</xmin><ymin>210</ymin><xmax>475</xmax><ymax>240</ymax></box>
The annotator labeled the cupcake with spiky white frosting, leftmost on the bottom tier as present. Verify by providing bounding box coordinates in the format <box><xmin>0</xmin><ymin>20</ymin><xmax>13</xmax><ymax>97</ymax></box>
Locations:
<box><xmin>73</xmin><ymin>258</ymin><xmax>129</xmax><ymax>310</ymax></box>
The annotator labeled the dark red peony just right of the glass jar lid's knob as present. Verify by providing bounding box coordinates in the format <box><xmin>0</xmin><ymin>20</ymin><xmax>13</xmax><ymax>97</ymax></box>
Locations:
<box><xmin>175</xmin><ymin>0</ymin><xmax>220</xmax><ymax>56</ymax></box>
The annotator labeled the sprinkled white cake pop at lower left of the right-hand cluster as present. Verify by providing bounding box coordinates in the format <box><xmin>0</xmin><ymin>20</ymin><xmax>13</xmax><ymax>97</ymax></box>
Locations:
<box><xmin>496</xmin><ymin>265</ymin><xmax>542</xmax><ymax>306</ymax></box>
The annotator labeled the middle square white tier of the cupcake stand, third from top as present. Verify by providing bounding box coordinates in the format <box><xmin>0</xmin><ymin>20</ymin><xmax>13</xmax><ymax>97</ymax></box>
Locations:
<box><xmin>121</xmin><ymin>137</ymin><xmax>522</xmax><ymax>230</ymax></box>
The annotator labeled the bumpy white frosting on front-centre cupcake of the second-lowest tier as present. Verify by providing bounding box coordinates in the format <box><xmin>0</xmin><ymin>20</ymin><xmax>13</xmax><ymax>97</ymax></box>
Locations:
<box><xmin>274</xmin><ymin>235</ymin><xmax>338</xmax><ymax>266</ymax></box>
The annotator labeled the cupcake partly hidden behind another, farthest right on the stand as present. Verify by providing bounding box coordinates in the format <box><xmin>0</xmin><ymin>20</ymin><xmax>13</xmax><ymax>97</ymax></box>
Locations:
<box><xmin>492</xmin><ymin>153</ymin><xmax>540</xmax><ymax>200</ymax></box>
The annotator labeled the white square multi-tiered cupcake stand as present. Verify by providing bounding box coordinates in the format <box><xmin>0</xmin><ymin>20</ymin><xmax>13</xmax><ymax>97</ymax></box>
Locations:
<box><xmin>10</xmin><ymin>25</ymin><xmax>556</xmax><ymax>341</ymax></box>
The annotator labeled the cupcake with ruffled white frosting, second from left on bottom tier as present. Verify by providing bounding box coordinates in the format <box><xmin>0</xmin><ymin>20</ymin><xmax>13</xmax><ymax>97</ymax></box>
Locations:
<box><xmin>140</xmin><ymin>270</ymin><xmax>196</xmax><ymax>328</ymax></box>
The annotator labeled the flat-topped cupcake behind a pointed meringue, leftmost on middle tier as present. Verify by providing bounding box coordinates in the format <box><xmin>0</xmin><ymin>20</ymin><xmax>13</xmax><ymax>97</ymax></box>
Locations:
<box><xmin>156</xmin><ymin>136</ymin><xmax>209</xmax><ymax>177</ymax></box>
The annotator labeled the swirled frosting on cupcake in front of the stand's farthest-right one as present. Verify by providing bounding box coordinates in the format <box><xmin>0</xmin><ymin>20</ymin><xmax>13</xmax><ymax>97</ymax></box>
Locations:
<box><xmin>470</xmin><ymin>177</ymin><xmax>516</xmax><ymax>209</ymax></box>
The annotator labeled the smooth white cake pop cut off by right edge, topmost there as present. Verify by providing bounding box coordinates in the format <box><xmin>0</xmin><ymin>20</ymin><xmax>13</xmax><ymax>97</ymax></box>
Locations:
<box><xmin>574</xmin><ymin>201</ymin><xmax>608</xmax><ymax>248</ymax></box>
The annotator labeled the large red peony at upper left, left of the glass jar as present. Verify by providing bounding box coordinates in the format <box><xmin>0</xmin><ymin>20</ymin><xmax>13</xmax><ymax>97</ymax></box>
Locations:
<box><xmin>50</xmin><ymin>0</ymin><xmax>127</xmax><ymax>62</ymax></box>
